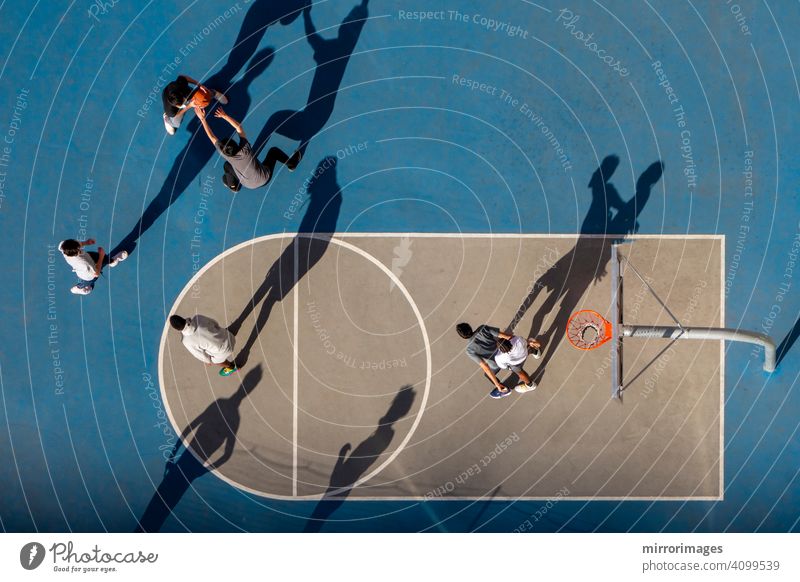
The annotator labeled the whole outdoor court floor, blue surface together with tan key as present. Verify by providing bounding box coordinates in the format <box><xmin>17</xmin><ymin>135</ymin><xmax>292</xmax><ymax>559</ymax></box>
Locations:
<box><xmin>0</xmin><ymin>0</ymin><xmax>800</xmax><ymax>532</ymax></box>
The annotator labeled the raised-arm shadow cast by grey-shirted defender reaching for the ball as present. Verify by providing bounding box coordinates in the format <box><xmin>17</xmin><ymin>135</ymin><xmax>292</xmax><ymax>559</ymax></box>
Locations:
<box><xmin>253</xmin><ymin>0</ymin><xmax>369</xmax><ymax>159</ymax></box>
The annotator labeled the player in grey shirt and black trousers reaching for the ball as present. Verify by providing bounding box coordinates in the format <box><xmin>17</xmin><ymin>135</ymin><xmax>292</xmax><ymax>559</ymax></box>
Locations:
<box><xmin>195</xmin><ymin>107</ymin><xmax>302</xmax><ymax>192</ymax></box>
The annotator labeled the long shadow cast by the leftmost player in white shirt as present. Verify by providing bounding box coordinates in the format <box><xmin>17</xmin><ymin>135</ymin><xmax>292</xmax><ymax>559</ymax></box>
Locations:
<box><xmin>110</xmin><ymin>48</ymin><xmax>275</xmax><ymax>257</ymax></box>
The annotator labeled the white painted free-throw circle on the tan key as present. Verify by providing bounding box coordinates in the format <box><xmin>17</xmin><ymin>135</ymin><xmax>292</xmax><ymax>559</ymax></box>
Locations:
<box><xmin>158</xmin><ymin>232</ymin><xmax>433</xmax><ymax>501</ymax></box>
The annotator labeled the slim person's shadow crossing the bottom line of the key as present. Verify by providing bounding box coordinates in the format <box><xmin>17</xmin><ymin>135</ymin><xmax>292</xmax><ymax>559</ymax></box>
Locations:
<box><xmin>304</xmin><ymin>386</ymin><xmax>416</xmax><ymax>532</ymax></box>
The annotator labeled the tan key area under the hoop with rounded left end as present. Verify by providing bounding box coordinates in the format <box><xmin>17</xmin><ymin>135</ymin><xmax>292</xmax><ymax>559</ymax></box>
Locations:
<box><xmin>160</xmin><ymin>234</ymin><xmax>724</xmax><ymax>499</ymax></box>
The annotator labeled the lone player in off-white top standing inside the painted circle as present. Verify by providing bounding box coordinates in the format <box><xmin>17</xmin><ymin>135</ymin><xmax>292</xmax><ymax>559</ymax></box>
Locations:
<box><xmin>169</xmin><ymin>314</ymin><xmax>236</xmax><ymax>376</ymax></box>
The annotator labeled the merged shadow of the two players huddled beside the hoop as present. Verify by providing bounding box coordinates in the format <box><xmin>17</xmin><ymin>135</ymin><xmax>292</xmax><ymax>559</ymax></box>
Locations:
<box><xmin>508</xmin><ymin>156</ymin><xmax>664</xmax><ymax>383</ymax></box>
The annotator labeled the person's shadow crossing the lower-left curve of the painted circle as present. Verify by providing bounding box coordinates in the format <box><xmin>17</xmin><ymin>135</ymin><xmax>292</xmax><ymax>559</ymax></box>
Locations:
<box><xmin>135</xmin><ymin>366</ymin><xmax>263</xmax><ymax>532</ymax></box>
